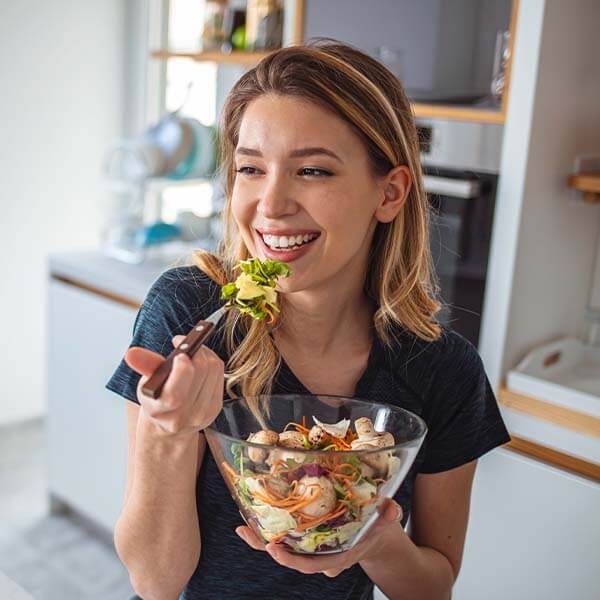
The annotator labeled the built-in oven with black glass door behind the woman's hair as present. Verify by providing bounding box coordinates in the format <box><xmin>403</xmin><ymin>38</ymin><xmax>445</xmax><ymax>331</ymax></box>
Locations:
<box><xmin>417</xmin><ymin>119</ymin><xmax>503</xmax><ymax>345</ymax></box>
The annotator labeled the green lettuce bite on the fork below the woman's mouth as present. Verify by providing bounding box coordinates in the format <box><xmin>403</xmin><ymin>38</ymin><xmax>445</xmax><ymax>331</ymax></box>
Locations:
<box><xmin>221</xmin><ymin>258</ymin><xmax>290</xmax><ymax>323</ymax></box>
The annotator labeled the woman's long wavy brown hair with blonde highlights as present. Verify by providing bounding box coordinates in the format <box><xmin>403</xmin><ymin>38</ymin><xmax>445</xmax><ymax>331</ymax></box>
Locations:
<box><xmin>193</xmin><ymin>38</ymin><xmax>441</xmax><ymax>422</ymax></box>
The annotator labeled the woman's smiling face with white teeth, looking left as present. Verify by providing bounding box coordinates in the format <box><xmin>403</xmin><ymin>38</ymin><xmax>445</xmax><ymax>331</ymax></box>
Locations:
<box><xmin>232</xmin><ymin>94</ymin><xmax>396</xmax><ymax>292</ymax></box>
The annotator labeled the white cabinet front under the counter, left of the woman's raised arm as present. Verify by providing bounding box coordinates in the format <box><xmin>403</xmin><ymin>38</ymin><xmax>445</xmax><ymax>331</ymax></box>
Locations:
<box><xmin>47</xmin><ymin>279</ymin><xmax>137</xmax><ymax>531</ymax></box>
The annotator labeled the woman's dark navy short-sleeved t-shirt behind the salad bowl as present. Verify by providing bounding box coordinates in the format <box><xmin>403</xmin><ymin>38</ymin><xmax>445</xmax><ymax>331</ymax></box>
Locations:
<box><xmin>106</xmin><ymin>267</ymin><xmax>510</xmax><ymax>600</ymax></box>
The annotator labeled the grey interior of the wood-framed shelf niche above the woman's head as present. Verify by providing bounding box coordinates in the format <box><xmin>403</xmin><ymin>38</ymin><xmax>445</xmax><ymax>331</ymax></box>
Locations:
<box><xmin>304</xmin><ymin>0</ymin><xmax>510</xmax><ymax>93</ymax></box>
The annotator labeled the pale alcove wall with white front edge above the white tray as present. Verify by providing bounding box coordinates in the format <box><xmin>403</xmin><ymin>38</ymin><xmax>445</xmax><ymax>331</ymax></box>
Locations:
<box><xmin>481</xmin><ymin>0</ymin><xmax>600</xmax><ymax>385</ymax></box>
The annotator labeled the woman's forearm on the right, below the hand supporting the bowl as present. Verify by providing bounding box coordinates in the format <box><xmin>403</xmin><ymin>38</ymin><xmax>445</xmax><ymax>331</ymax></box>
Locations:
<box><xmin>360</xmin><ymin>523</ymin><xmax>454</xmax><ymax>600</ymax></box>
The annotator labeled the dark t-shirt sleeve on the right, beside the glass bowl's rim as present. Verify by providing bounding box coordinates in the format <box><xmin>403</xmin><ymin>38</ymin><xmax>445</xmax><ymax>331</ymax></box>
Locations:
<box><xmin>419</xmin><ymin>334</ymin><xmax>510</xmax><ymax>473</ymax></box>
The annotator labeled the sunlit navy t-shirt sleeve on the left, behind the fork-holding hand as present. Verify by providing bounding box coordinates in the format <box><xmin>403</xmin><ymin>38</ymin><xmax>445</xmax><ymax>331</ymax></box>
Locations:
<box><xmin>105</xmin><ymin>267</ymin><xmax>214</xmax><ymax>404</ymax></box>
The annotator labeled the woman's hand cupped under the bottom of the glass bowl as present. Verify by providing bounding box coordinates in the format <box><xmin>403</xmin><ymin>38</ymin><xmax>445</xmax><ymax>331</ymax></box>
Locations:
<box><xmin>235</xmin><ymin>499</ymin><xmax>402</xmax><ymax>577</ymax></box>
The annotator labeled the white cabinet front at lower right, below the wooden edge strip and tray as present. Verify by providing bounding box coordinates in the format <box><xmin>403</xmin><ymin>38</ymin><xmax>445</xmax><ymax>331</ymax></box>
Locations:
<box><xmin>453</xmin><ymin>449</ymin><xmax>600</xmax><ymax>600</ymax></box>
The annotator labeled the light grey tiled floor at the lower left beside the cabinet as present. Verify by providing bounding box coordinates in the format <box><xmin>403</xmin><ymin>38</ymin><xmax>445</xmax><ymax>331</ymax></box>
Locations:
<box><xmin>0</xmin><ymin>419</ymin><xmax>133</xmax><ymax>600</ymax></box>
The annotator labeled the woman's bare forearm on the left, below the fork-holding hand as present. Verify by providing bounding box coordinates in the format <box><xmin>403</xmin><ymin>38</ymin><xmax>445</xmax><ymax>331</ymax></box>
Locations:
<box><xmin>114</xmin><ymin>411</ymin><xmax>200</xmax><ymax>600</ymax></box>
